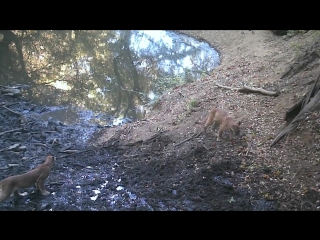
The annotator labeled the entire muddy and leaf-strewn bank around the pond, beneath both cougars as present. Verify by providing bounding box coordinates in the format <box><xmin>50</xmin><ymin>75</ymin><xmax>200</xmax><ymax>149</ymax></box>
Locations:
<box><xmin>0</xmin><ymin>31</ymin><xmax>320</xmax><ymax>211</ymax></box>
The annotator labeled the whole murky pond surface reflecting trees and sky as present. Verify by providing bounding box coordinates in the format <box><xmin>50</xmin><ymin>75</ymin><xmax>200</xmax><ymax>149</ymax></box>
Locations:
<box><xmin>0</xmin><ymin>30</ymin><xmax>218</xmax><ymax>118</ymax></box>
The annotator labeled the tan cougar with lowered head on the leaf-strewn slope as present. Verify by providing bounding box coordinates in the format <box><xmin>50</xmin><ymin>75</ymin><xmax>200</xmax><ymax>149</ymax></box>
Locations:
<box><xmin>199</xmin><ymin>108</ymin><xmax>240</xmax><ymax>141</ymax></box>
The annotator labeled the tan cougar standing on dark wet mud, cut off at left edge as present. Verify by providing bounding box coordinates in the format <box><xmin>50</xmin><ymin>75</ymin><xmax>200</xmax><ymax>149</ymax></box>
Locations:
<box><xmin>0</xmin><ymin>156</ymin><xmax>56</xmax><ymax>202</ymax></box>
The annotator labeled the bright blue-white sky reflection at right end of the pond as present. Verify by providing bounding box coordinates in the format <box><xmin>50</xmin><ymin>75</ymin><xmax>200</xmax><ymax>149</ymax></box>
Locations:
<box><xmin>131</xmin><ymin>31</ymin><xmax>218</xmax><ymax>95</ymax></box>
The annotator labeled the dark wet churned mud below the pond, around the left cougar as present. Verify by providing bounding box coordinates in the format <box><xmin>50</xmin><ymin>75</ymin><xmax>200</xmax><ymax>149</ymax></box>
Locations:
<box><xmin>0</xmin><ymin>95</ymin><xmax>276</xmax><ymax>211</ymax></box>
